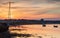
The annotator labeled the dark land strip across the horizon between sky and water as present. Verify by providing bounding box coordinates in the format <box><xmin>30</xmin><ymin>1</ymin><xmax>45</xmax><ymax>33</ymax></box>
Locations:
<box><xmin>0</xmin><ymin>19</ymin><xmax>60</xmax><ymax>25</ymax></box>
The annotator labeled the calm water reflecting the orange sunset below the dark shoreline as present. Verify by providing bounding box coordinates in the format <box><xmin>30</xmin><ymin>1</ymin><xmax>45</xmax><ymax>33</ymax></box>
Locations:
<box><xmin>9</xmin><ymin>24</ymin><xmax>60</xmax><ymax>38</ymax></box>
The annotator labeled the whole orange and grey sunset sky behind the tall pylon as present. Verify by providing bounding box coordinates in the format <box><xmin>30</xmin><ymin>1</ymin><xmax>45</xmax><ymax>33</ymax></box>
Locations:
<box><xmin>0</xmin><ymin>0</ymin><xmax>60</xmax><ymax>19</ymax></box>
